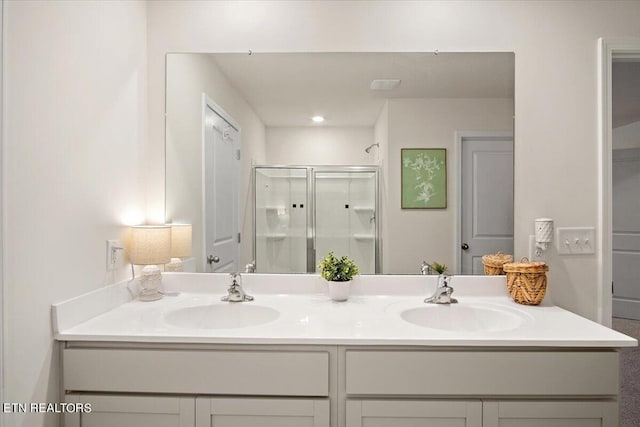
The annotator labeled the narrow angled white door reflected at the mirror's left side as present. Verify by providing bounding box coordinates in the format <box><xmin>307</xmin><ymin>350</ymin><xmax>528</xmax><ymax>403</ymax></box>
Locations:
<box><xmin>203</xmin><ymin>103</ymin><xmax>240</xmax><ymax>272</ymax></box>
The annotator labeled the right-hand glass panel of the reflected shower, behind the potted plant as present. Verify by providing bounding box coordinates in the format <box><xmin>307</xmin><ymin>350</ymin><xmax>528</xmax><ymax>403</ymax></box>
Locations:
<box><xmin>314</xmin><ymin>170</ymin><xmax>377</xmax><ymax>274</ymax></box>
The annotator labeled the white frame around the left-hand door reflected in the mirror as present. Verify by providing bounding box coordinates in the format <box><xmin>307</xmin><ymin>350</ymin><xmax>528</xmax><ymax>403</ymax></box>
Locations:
<box><xmin>200</xmin><ymin>92</ymin><xmax>242</xmax><ymax>271</ymax></box>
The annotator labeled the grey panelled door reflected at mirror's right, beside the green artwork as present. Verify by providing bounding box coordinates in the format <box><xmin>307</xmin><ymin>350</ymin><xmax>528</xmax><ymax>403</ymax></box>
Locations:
<box><xmin>458</xmin><ymin>134</ymin><xmax>513</xmax><ymax>274</ymax></box>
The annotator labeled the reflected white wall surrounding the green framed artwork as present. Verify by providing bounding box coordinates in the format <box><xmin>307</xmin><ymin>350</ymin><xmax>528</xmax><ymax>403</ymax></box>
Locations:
<box><xmin>384</xmin><ymin>99</ymin><xmax>517</xmax><ymax>273</ymax></box>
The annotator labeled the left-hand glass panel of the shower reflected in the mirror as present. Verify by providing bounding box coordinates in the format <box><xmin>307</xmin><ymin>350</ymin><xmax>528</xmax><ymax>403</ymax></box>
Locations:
<box><xmin>254</xmin><ymin>167</ymin><xmax>309</xmax><ymax>273</ymax></box>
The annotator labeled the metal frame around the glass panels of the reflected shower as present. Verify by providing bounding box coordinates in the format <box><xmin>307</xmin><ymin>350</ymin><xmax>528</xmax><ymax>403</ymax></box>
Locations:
<box><xmin>251</xmin><ymin>165</ymin><xmax>382</xmax><ymax>274</ymax></box>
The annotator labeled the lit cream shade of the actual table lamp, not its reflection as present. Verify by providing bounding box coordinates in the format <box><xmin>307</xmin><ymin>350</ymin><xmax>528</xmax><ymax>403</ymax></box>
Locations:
<box><xmin>129</xmin><ymin>225</ymin><xmax>171</xmax><ymax>265</ymax></box>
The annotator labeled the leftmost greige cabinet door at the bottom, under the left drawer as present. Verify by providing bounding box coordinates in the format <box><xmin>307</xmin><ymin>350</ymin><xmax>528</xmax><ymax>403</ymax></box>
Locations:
<box><xmin>64</xmin><ymin>394</ymin><xmax>195</xmax><ymax>427</ymax></box>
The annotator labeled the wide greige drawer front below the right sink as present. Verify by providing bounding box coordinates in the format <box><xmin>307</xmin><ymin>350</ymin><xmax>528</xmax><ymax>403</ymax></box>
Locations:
<box><xmin>346</xmin><ymin>350</ymin><xmax>619</xmax><ymax>396</ymax></box>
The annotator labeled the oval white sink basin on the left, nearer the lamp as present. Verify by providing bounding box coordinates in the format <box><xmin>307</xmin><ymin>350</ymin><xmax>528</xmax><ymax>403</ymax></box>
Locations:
<box><xmin>165</xmin><ymin>303</ymin><xmax>280</xmax><ymax>329</ymax></box>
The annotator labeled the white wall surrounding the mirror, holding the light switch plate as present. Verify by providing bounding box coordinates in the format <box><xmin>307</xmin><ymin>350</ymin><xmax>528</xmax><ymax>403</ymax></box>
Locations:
<box><xmin>147</xmin><ymin>1</ymin><xmax>640</xmax><ymax>319</ymax></box>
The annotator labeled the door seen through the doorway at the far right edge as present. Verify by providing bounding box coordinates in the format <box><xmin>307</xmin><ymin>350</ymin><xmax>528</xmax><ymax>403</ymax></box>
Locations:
<box><xmin>612</xmin><ymin>148</ymin><xmax>640</xmax><ymax>320</ymax></box>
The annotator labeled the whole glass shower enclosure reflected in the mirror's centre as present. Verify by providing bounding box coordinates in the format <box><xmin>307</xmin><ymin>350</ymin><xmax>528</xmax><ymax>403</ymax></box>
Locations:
<box><xmin>253</xmin><ymin>166</ymin><xmax>380</xmax><ymax>274</ymax></box>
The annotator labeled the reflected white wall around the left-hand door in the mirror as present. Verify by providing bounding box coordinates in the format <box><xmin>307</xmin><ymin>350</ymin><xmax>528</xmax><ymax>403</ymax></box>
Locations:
<box><xmin>166</xmin><ymin>54</ymin><xmax>265</xmax><ymax>271</ymax></box>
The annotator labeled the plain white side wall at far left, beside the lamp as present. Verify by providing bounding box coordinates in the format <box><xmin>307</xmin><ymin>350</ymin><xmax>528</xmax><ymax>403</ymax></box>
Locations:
<box><xmin>2</xmin><ymin>1</ymin><xmax>146</xmax><ymax>427</ymax></box>
